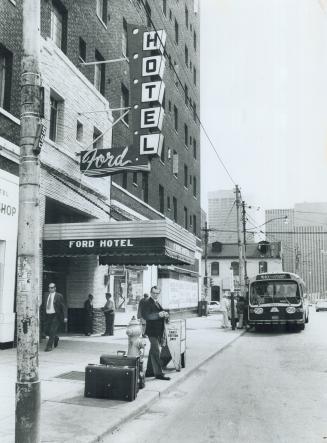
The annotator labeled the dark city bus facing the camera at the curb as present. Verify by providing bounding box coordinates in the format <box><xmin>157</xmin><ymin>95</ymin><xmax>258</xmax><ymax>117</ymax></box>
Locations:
<box><xmin>248</xmin><ymin>272</ymin><xmax>309</xmax><ymax>330</ymax></box>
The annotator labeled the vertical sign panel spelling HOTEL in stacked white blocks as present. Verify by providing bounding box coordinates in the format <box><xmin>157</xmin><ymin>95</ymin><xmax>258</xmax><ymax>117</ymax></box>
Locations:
<box><xmin>127</xmin><ymin>25</ymin><xmax>166</xmax><ymax>156</ymax></box>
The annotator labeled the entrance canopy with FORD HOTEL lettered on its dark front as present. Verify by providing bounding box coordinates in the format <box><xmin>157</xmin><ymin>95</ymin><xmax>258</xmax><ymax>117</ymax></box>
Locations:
<box><xmin>43</xmin><ymin>219</ymin><xmax>196</xmax><ymax>265</ymax></box>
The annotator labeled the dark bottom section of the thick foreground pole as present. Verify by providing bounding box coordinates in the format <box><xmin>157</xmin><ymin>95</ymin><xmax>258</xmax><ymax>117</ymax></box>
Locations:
<box><xmin>15</xmin><ymin>381</ymin><xmax>41</xmax><ymax>443</ymax></box>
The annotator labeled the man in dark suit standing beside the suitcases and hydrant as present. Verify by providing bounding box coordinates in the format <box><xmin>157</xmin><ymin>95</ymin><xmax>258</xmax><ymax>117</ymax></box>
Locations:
<box><xmin>142</xmin><ymin>286</ymin><xmax>170</xmax><ymax>380</ymax></box>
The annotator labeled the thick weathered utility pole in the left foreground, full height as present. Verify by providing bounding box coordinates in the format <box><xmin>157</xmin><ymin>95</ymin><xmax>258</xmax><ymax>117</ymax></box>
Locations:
<box><xmin>15</xmin><ymin>0</ymin><xmax>41</xmax><ymax>443</ymax></box>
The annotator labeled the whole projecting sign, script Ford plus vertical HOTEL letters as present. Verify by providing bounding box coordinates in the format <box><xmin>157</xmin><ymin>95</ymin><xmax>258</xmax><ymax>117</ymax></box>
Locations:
<box><xmin>80</xmin><ymin>25</ymin><xmax>166</xmax><ymax>177</ymax></box>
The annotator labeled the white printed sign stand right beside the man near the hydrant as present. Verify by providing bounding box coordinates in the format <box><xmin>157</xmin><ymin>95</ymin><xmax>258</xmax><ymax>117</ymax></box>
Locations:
<box><xmin>165</xmin><ymin>319</ymin><xmax>186</xmax><ymax>371</ymax></box>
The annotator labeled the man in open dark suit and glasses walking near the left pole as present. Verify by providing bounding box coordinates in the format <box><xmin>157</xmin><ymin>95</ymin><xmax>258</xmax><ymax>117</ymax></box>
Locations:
<box><xmin>41</xmin><ymin>283</ymin><xmax>67</xmax><ymax>352</ymax></box>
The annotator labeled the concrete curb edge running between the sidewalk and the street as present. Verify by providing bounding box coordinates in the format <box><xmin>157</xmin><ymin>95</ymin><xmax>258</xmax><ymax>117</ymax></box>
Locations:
<box><xmin>89</xmin><ymin>330</ymin><xmax>247</xmax><ymax>443</ymax></box>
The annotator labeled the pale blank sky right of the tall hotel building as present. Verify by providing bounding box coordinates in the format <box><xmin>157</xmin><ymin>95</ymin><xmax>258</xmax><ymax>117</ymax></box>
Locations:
<box><xmin>200</xmin><ymin>0</ymin><xmax>327</xmax><ymax>218</ymax></box>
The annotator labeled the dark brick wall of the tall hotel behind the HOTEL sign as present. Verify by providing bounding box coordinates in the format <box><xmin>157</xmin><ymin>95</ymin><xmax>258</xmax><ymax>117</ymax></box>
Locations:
<box><xmin>0</xmin><ymin>0</ymin><xmax>201</xmax><ymax>235</ymax></box>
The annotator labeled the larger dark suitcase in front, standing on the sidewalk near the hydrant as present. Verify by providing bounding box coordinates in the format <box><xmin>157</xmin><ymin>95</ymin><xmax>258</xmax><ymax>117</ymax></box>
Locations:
<box><xmin>84</xmin><ymin>364</ymin><xmax>136</xmax><ymax>401</ymax></box>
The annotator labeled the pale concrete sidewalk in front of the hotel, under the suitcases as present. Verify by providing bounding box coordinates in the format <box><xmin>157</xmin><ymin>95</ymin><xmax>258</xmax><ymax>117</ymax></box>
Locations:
<box><xmin>0</xmin><ymin>315</ymin><xmax>242</xmax><ymax>443</ymax></box>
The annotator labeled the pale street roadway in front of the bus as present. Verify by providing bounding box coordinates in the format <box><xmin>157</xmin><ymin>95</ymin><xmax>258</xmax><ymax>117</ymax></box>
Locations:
<box><xmin>103</xmin><ymin>308</ymin><xmax>327</xmax><ymax>443</ymax></box>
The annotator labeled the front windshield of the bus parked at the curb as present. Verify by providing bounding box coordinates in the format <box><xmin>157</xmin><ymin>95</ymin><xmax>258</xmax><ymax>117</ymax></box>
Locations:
<box><xmin>250</xmin><ymin>281</ymin><xmax>301</xmax><ymax>305</ymax></box>
